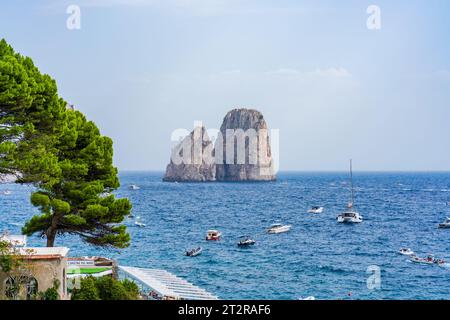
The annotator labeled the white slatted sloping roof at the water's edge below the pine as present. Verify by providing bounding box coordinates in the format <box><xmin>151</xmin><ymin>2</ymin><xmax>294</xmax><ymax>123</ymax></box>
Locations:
<box><xmin>119</xmin><ymin>266</ymin><xmax>218</xmax><ymax>300</ymax></box>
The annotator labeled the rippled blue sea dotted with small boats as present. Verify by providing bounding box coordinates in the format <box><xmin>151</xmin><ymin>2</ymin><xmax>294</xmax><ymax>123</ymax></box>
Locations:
<box><xmin>0</xmin><ymin>172</ymin><xmax>450</xmax><ymax>299</ymax></box>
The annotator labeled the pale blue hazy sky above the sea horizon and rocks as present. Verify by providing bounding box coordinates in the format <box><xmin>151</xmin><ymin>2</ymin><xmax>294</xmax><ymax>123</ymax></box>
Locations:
<box><xmin>0</xmin><ymin>0</ymin><xmax>450</xmax><ymax>171</ymax></box>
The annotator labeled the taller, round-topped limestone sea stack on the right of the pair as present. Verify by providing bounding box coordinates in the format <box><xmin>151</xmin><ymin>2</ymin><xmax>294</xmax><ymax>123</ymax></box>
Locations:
<box><xmin>215</xmin><ymin>109</ymin><xmax>276</xmax><ymax>181</ymax></box>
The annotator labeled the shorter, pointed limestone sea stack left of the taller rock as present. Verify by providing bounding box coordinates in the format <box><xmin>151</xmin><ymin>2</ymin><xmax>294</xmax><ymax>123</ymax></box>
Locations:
<box><xmin>163</xmin><ymin>126</ymin><xmax>216</xmax><ymax>182</ymax></box>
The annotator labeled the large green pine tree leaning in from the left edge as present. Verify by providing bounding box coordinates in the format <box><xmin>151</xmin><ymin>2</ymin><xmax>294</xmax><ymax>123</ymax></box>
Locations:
<box><xmin>0</xmin><ymin>40</ymin><xmax>131</xmax><ymax>248</ymax></box>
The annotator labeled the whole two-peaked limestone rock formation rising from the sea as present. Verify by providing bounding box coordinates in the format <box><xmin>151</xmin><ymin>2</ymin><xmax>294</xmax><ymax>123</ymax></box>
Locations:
<box><xmin>163</xmin><ymin>109</ymin><xmax>276</xmax><ymax>182</ymax></box>
